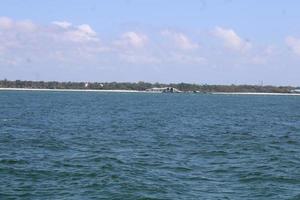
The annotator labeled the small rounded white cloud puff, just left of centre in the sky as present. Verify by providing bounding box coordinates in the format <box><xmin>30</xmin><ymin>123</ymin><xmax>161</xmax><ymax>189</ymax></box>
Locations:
<box><xmin>114</xmin><ymin>31</ymin><xmax>149</xmax><ymax>48</ymax></box>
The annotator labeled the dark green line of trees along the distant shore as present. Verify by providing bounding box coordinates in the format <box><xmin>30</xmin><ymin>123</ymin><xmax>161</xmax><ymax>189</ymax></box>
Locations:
<box><xmin>0</xmin><ymin>80</ymin><xmax>296</xmax><ymax>93</ymax></box>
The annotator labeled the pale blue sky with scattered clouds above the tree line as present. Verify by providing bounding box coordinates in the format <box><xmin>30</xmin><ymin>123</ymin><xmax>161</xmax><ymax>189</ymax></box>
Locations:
<box><xmin>0</xmin><ymin>0</ymin><xmax>300</xmax><ymax>86</ymax></box>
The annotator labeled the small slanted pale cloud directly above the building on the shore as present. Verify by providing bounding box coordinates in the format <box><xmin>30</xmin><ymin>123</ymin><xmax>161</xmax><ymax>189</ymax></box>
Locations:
<box><xmin>161</xmin><ymin>30</ymin><xmax>199</xmax><ymax>50</ymax></box>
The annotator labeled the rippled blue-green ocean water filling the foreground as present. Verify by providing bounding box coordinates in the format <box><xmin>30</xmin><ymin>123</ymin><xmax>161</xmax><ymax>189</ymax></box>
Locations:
<box><xmin>0</xmin><ymin>91</ymin><xmax>300</xmax><ymax>200</ymax></box>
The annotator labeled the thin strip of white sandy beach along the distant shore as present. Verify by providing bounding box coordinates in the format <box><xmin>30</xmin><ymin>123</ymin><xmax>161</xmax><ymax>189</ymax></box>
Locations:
<box><xmin>0</xmin><ymin>88</ymin><xmax>300</xmax><ymax>96</ymax></box>
